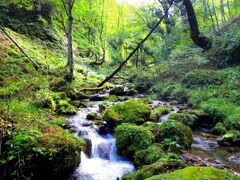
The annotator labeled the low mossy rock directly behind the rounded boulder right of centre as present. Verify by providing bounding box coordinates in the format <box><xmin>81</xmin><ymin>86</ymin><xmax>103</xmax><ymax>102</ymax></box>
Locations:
<box><xmin>169</xmin><ymin>113</ymin><xmax>197</xmax><ymax>129</ymax></box>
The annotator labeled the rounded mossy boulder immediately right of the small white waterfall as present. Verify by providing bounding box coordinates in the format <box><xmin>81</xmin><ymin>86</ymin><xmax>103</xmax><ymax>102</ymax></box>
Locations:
<box><xmin>115</xmin><ymin>123</ymin><xmax>154</xmax><ymax>159</ymax></box>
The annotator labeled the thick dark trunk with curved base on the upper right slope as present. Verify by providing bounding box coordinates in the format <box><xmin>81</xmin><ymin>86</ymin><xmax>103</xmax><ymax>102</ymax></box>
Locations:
<box><xmin>183</xmin><ymin>0</ymin><xmax>212</xmax><ymax>50</ymax></box>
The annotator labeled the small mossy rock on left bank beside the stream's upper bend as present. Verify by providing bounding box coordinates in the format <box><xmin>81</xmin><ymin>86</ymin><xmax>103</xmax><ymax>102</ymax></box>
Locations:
<box><xmin>56</xmin><ymin>100</ymin><xmax>77</xmax><ymax>115</ymax></box>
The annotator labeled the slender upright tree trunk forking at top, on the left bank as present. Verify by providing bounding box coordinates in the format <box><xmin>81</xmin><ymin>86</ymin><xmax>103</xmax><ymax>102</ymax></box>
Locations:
<box><xmin>62</xmin><ymin>0</ymin><xmax>75</xmax><ymax>83</ymax></box>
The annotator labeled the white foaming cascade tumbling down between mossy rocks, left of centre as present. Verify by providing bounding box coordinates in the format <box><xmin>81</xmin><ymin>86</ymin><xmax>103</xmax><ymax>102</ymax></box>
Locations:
<box><xmin>69</xmin><ymin>102</ymin><xmax>134</xmax><ymax>180</ymax></box>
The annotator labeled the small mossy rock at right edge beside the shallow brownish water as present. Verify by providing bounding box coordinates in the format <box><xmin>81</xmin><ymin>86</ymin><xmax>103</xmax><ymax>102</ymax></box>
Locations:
<box><xmin>218</xmin><ymin>130</ymin><xmax>240</xmax><ymax>146</ymax></box>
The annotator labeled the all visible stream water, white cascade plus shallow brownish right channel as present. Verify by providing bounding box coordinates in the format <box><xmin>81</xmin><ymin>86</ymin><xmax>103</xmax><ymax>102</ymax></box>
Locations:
<box><xmin>68</xmin><ymin>95</ymin><xmax>240</xmax><ymax>180</ymax></box>
